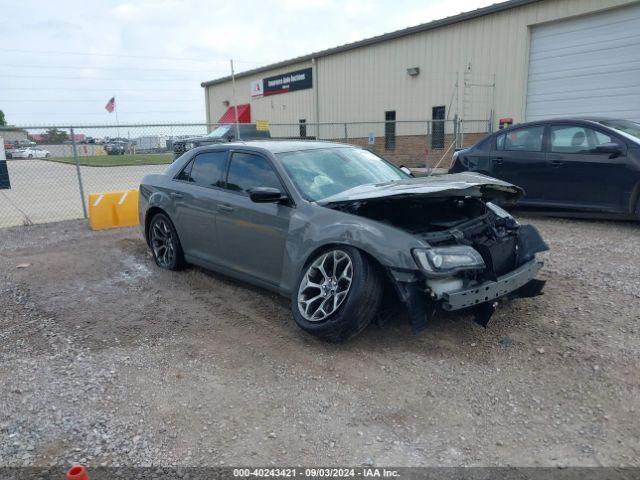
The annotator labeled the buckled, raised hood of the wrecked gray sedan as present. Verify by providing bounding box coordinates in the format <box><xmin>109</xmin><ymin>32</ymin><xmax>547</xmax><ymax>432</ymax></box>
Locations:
<box><xmin>318</xmin><ymin>172</ymin><xmax>524</xmax><ymax>205</ymax></box>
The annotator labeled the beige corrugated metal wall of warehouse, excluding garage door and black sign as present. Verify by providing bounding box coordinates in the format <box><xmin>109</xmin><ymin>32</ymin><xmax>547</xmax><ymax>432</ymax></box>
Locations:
<box><xmin>207</xmin><ymin>0</ymin><xmax>637</xmax><ymax>129</ymax></box>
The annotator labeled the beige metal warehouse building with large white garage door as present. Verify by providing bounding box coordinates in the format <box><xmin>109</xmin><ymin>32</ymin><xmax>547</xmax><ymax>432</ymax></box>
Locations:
<box><xmin>202</xmin><ymin>0</ymin><xmax>640</xmax><ymax>167</ymax></box>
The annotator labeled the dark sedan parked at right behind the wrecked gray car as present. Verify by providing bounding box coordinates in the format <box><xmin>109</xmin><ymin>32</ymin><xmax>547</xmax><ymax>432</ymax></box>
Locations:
<box><xmin>449</xmin><ymin>118</ymin><xmax>640</xmax><ymax>219</ymax></box>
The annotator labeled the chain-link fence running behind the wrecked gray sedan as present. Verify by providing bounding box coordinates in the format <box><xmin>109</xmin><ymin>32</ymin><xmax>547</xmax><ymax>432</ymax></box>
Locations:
<box><xmin>0</xmin><ymin>120</ymin><xmax>490</xmax><ymax>227</ymax></box>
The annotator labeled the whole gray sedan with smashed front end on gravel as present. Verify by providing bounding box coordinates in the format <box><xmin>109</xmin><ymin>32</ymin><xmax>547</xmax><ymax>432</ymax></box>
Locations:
<box><xmin>139</xmin><ymin>141</ymin><xmax>547</xmax><ymax>341</ymax></box>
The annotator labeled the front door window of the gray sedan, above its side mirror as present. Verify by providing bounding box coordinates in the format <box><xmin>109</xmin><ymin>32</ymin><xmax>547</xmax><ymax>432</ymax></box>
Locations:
<box><xmin>227</xmin><ymin>153</ymin><xmax>282</xmax><ymax>194</ymax></box>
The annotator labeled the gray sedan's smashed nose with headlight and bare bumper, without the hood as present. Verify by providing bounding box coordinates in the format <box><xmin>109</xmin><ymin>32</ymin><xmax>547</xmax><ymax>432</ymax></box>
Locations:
<box><xmin>389</xmin><ymin>204</ymin><xmax>548</xmax><ymax>333</ymax></box>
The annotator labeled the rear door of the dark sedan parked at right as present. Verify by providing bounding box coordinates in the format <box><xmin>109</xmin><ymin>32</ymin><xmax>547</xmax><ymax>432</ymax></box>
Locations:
<box><xmin>490</xmin><ymin>124</ymin><xmax>548</xmax><ymax>203</ymax></box>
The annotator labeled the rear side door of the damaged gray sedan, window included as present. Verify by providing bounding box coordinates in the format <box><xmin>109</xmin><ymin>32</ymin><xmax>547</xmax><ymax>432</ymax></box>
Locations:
<box><xmin>170</xmin><ymin>150</ymin><xmax>228</xmax><ymax>262</ymax></box>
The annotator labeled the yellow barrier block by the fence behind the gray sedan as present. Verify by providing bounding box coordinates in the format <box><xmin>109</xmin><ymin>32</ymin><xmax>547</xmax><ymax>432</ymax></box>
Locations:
<box><xmin>89</xmin><ymin>190</ymin><xmax>139</xmax><ymax>230</ymax></box>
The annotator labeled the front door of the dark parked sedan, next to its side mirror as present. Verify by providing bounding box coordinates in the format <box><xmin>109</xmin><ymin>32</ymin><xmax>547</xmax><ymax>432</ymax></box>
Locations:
<box><xmin>545</xmin><ymin>122</ymin><xmax>633</xmax><ymax>211</ymax></box>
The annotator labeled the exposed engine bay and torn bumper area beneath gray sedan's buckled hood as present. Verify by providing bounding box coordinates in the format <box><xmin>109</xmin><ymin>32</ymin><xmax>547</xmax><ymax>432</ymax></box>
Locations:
<box><xmin>332</xmin><ymin>195</ymin><xmax>548</xmax><ymax>332</ymax></box>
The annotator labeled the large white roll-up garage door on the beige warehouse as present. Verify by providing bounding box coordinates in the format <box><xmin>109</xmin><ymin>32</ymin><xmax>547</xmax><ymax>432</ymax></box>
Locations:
<box><xmin>526</xmin><ymin>4</ymin><xmax>640</xmax><ymax>121</ymax></box>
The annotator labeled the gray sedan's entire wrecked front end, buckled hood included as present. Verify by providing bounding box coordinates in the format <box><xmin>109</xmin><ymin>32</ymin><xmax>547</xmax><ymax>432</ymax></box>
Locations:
<box><xmin>323</xmin><ymin>173</ymin><xmax>548</xmax><ymax>332</ymax></box>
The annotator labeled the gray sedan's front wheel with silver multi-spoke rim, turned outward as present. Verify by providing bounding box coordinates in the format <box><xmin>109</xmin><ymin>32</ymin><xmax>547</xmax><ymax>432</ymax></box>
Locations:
<box><xmin>291</xmin><ymin>246</ymin><xmax>382</xmax><ymax>342</ymax></box>
